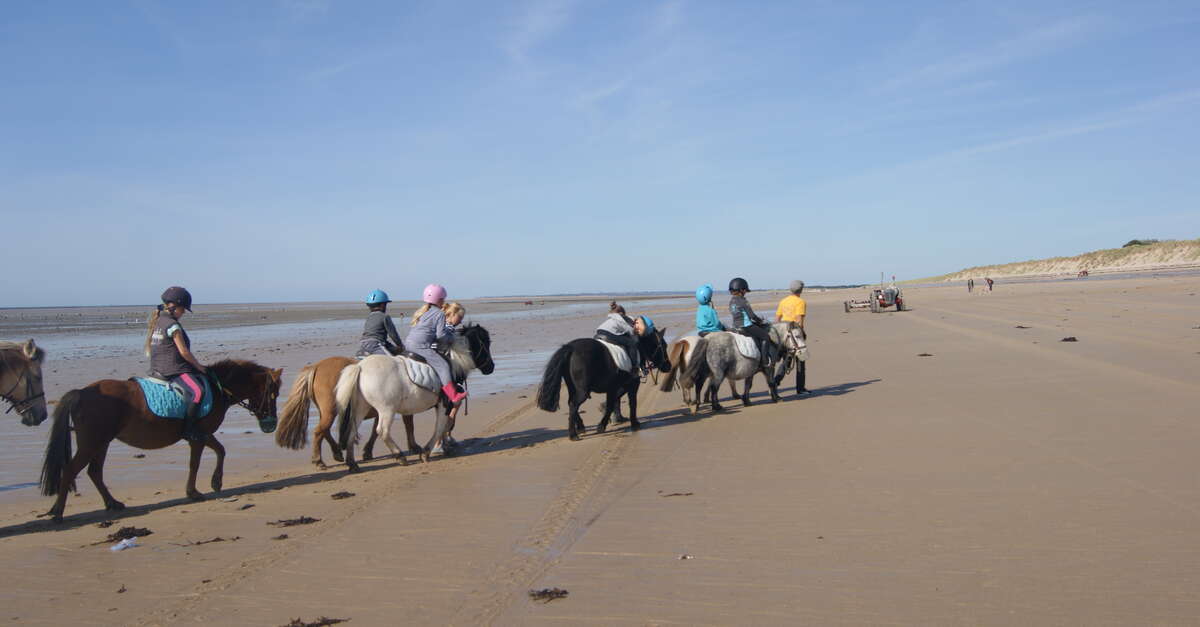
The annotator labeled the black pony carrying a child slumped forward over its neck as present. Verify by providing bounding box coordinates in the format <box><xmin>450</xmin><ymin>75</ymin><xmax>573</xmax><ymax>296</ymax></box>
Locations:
<box><xmin>538</xmin><ymin>329</ymin><xmax>671</xmax><ymax>440</ymax></box>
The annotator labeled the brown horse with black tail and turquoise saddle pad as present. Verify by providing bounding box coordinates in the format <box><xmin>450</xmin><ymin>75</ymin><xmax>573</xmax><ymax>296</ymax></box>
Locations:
<box><xmin>42</xmin><ymin>359</ymin><xmax>283</xmax><ymax>523</ymax></box>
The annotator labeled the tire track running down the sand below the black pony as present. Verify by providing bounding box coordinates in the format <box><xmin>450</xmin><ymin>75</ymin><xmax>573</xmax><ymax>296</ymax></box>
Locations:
<box><xmin>449</xmin><ymin>379</ymin><xmax>662</xmax><ymax>625</ymax></box>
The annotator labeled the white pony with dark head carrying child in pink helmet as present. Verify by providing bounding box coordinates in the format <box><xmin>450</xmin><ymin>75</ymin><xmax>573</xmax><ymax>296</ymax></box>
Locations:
<box><xmin>334</xmin><ymin>324</ymin><xmax>496</xmax><ymax>472</ymax></box>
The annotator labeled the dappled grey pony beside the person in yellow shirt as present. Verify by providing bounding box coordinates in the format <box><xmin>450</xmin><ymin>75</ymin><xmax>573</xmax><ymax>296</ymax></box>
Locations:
<box><xmin>680</xmin><ymin>322</ymin><xmax>787</xmax><ymax>412</ymax></box>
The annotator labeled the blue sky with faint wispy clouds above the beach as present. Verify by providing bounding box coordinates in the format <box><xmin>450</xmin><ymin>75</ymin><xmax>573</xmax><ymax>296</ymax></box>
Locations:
<box><xmin>0</xmin><ymin>0</ymin><xmax>1200</xmax><ymax>306</ymax></box>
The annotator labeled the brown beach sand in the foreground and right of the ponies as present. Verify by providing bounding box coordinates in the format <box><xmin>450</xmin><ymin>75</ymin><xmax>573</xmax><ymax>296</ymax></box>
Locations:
<box><xmin>0</xmin><ymin>276</ymin><xmax>1200</xmax><ymax>626</ymax></box>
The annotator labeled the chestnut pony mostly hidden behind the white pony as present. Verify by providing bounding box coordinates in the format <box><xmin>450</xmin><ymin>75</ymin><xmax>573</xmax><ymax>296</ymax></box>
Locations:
<box><xmin>275</xmin><ymin>357</ymin><xmax>422</xmax><ymax>468</ymax></box>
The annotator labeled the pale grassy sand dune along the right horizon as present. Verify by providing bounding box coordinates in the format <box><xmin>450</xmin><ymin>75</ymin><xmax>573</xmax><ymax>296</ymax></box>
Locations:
<box><xmin>920</xmin><ymin>239</ymin><xmax>1200</xmax><ymax>282</ymax></box>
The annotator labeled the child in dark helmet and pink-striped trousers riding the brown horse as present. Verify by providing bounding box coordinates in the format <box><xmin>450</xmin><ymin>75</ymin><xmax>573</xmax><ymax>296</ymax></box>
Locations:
<box><xmin>145</xmin><ymin>286</ymin><xmax>209</xmax><ymax>442</ymax></box>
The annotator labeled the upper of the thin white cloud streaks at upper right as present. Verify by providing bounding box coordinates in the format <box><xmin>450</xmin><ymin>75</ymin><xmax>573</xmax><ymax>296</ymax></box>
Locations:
<box><xmin>880</xmin><ymin>16</ymin><xmax>1105</xmax><ymax>91</ymax></box>
